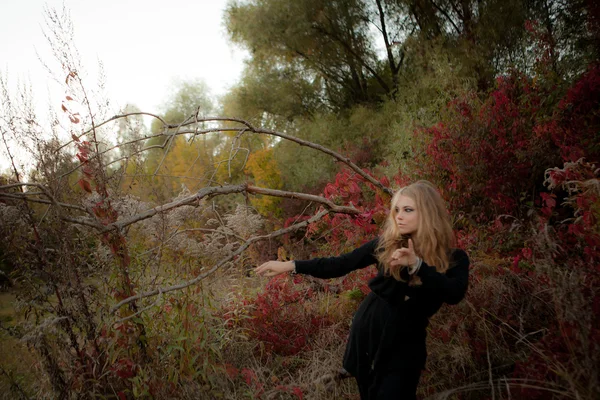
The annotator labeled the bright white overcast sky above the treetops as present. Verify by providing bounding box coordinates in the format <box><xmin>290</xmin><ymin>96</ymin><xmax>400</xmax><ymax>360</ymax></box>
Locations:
<box><xmin>0</xmin><ymin>0</ymin><xmax>245</xmax><ymax>170</ymax></box>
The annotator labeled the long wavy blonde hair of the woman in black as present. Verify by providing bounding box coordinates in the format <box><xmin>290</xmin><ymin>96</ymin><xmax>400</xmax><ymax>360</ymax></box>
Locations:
<box><xmin>376</xmin><ymin>181</ymin><xmax>455</xmax><ymax>280</ymax></box>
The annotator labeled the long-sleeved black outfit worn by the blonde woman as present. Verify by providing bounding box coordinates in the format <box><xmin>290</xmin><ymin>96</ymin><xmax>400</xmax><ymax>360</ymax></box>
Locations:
<box><xmin>295</xmin><ymin>239</ymin><xmax>469</xmax><ymax>399</ymax></box>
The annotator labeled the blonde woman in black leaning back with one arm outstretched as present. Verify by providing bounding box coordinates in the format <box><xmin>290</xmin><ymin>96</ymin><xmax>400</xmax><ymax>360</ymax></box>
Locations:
<box><xmin>256</xmin><ymin>181</ymin><xmax>469</xmax><ymax>400</ymax></box>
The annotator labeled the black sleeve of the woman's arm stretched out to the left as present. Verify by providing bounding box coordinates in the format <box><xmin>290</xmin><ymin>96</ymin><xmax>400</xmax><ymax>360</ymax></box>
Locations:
<box><xmin>295</xmin><ymin>239</ymin><xmax>379</xmax><ymax>278</ymax></box>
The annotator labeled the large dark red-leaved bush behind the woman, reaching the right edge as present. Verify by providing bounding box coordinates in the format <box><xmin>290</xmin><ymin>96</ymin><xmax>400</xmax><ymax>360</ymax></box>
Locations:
<box><xmin>416</xmin><ymin>65</ymin><xmax>600</xmax><ymax>222</ymax></box>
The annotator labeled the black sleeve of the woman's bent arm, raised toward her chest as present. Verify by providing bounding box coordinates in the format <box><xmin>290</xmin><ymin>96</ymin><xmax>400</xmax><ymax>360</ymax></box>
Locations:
<box><xmin>417</xmin><ymin>250</ymin><xmax>469</xmax><ymax>304</ymax></box>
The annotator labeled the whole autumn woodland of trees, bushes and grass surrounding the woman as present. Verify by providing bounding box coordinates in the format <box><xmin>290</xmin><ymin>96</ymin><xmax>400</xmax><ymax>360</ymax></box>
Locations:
<box><xmin>0</xmin><ymin>0</ymin><xmax>600</xmax><ymax>400</ymax></box>
